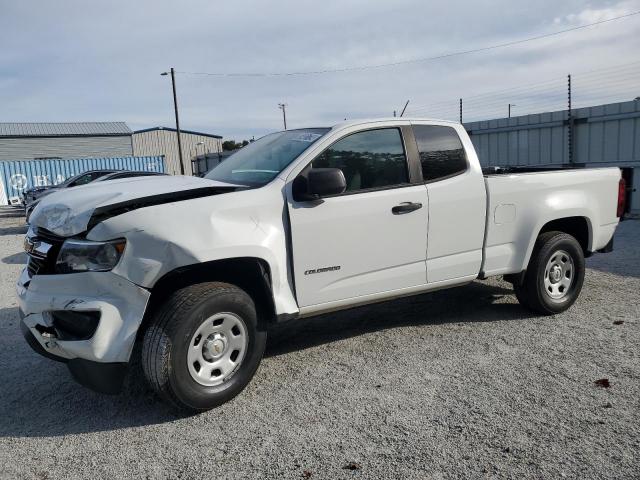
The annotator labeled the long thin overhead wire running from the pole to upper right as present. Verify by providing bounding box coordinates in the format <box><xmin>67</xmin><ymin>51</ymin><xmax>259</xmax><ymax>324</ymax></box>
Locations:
<box><xmin>176</xmin><ymin>10</ymin><xmax>640</xmax><ymax>77</ymax></box>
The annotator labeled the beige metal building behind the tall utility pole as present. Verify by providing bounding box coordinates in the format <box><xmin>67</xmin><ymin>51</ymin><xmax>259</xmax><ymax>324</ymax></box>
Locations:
<box><xmin>132</xmin><ymin>127</ymin><xmax>222</xmax><ymax>175</ymax></box>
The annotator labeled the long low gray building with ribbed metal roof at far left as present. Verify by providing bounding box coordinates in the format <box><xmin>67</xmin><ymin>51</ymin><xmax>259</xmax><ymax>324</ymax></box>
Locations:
<box><xmin>0</xmin><ymin>122</ymin><xmax>133</xmax><ymax>161</ymax></box>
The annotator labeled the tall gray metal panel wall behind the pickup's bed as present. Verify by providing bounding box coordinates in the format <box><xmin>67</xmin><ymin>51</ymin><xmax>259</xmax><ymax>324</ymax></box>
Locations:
<box><xmin>465</xmin><ymin>101</ymin><xmax>640</xmax><ymax>167</ymax></box>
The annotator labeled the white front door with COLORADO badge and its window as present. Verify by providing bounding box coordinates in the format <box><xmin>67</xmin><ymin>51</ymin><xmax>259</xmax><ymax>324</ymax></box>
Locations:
<box><xmin>288</xmin><ymin>127</ymin><xmax>429</xmax><ymax>307</ymax></box>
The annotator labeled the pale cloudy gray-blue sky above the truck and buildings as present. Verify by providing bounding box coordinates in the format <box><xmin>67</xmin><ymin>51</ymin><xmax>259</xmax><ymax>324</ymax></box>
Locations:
<box><xmin>0</xmin><ymin>0</ymin><xmax>640</xmax><ymax>139</ymax></box>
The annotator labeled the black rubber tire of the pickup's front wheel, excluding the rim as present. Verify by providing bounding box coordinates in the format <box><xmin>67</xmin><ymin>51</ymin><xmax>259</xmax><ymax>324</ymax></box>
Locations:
<box><xmin>142</xmin><ymin>282</ymin><xmax>267</xmax><ymax>412</ymax></box>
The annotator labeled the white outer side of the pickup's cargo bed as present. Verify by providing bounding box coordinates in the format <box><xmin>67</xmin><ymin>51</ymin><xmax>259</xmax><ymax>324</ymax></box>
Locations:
<box><xmin>482</xmin><ymin>167</ymin><xmax>620</xmax><ymax>276</ymax></box>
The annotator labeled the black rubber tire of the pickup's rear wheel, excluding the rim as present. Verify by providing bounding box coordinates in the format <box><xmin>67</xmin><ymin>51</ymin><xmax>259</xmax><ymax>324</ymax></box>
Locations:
<box><xmin>513</xmin><ymin>232</ymin><xmax>585</xmax><ymax>315</ymax></box>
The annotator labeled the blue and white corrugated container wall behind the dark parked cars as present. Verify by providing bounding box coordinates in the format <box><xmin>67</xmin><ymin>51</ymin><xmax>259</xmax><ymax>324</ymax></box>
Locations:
<box><xmin>0</xmin><ymin>156</ymin><xmax>165</xmax><ymax>205</ymax></box>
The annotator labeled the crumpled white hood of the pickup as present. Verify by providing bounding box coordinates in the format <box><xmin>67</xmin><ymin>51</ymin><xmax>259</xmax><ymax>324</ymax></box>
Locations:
<box><xmin>30</xmin><ymin>176</ymin><xmax>242</xmax><ymax>237</ymax></box>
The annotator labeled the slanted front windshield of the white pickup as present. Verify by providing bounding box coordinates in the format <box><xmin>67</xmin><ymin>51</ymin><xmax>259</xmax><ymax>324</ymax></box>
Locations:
<box><xmin>205</xmin><ymin>128</ymin><xmax>330</xmax><ymax>187</ymax></box>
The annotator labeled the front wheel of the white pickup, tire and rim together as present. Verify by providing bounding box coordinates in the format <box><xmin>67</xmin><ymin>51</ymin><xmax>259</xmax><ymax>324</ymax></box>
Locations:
<box><xmin>142</xmin><ymin>282</ymin><xmax>267</xmax><ymax>412</ymax></box>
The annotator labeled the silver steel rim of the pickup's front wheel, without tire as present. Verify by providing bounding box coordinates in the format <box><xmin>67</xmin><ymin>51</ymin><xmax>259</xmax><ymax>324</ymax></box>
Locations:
<box><xmin>187</xmin><ymin>312</ymin><xmax>249</xmax><ymax>387</ymax></box>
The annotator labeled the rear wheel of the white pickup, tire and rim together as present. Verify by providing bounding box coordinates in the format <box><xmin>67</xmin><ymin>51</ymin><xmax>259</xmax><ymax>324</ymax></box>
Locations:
<box><xmin>514</xmin><ymin>232</ymin><xmax>585</xmax><ymax>315</ymax></box>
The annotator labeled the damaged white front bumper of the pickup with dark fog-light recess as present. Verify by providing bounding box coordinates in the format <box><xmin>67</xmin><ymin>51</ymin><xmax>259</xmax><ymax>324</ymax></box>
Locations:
<box><xmin>16</xmin><ymin>269</ymin><xmax>150</xmax><ymax>393</ymax></box>
